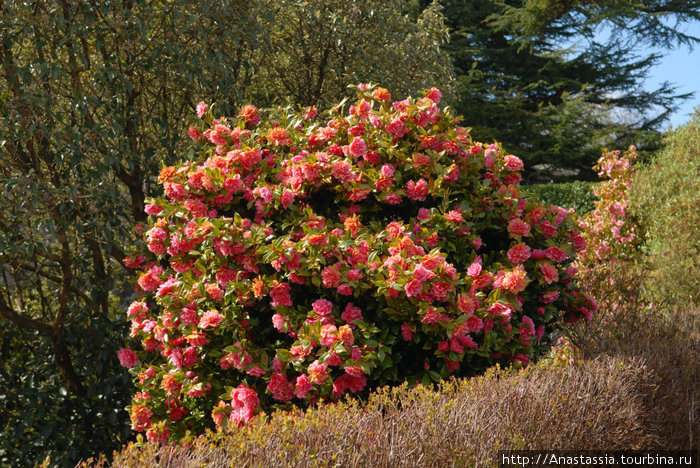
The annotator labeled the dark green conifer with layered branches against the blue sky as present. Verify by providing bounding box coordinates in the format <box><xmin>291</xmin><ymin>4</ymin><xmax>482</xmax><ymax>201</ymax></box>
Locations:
<box><xmin>426</xmin><ymin>0</ymin><xmax>700</xmax><ymax>182</ymax></box>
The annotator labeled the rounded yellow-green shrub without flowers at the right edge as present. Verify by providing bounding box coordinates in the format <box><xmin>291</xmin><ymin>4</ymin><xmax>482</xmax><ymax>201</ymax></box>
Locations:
<box><xmin>630</xmin><ymin>110</ymin><xmax>700</xmax><ymax>306</ymax></box>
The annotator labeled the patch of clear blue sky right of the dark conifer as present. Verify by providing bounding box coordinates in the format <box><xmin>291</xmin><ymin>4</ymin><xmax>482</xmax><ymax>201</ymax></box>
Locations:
<box><xmin>640</xmin><ymin>23</ymin><xmax>700</xmax><ymax>127</ymax></box>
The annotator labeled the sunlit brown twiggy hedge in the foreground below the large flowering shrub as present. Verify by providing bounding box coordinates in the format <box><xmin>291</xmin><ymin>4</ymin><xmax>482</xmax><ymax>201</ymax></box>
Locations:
<box><xmin>85</xmin><ymin>357</ymin><xmax>660</xmax><ymax>467</ymax></box>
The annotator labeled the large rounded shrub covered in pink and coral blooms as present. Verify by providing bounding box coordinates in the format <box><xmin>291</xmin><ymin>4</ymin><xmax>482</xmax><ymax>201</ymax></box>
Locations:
<box><xmin>120</xmin><ymin>85</ymin><xmax>595</xmax><ymax>442</ymax></box>
